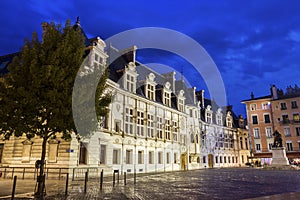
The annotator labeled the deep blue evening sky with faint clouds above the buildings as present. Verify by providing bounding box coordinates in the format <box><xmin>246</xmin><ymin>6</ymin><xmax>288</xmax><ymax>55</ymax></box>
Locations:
<box><xmin>0</xmin><ymin>0</ymin><xmax>300</xmax><ymax>115</ymax></box>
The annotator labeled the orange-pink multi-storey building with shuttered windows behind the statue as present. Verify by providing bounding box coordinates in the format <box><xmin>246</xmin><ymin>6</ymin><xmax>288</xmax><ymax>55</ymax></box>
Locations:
<box><xmin>242</xmin><ymin>85</ymin><xmax>300</xmax><ymax>164</ymax></box>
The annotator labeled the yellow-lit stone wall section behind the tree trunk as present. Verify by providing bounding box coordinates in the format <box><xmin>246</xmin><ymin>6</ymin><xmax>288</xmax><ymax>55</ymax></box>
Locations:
<box><xmin>0</xmin><ymin>134</ymin><xmax>74</xmax><ymax>168</ymax></box>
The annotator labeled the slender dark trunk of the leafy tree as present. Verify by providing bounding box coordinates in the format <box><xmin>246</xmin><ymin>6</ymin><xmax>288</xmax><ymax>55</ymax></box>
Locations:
<box><xmin>36</xmin><ymin>137</ymin><xmax>48</xmax><ymax>199</ymax></box>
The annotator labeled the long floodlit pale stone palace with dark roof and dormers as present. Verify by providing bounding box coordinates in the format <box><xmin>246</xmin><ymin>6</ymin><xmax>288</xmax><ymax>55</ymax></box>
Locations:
<box><xmin>0</xmin><ymin>19</ymin><xmax>249</xmax><ymax>177</ymax></box>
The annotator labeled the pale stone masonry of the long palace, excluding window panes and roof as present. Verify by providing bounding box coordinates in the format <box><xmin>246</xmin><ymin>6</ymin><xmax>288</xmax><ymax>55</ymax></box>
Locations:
<box><xmin>0</xmin><ymin>39</ymin><xmax>250</xmax><ymax>173</ymax></box>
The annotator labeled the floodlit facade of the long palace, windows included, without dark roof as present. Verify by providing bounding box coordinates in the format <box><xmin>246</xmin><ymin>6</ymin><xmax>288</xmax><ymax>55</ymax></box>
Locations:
<box><xmin>0</xmin><ymin>35</ymin><xmax>246</xmax><ymax>173</ymax></box>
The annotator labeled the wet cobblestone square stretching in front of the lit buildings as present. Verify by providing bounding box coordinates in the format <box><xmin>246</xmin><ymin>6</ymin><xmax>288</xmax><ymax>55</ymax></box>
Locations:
<box><xmin>0</xmin><ymin>168</ymin><xmax>300</xmax><ymax>200</ymax></box>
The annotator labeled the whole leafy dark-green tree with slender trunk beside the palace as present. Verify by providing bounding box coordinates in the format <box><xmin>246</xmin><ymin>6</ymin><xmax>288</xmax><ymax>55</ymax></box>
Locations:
<box><xmin>0</xmin><ymin>21</ymin><xmax>110</xmax><ymax>198</ymax></box>
